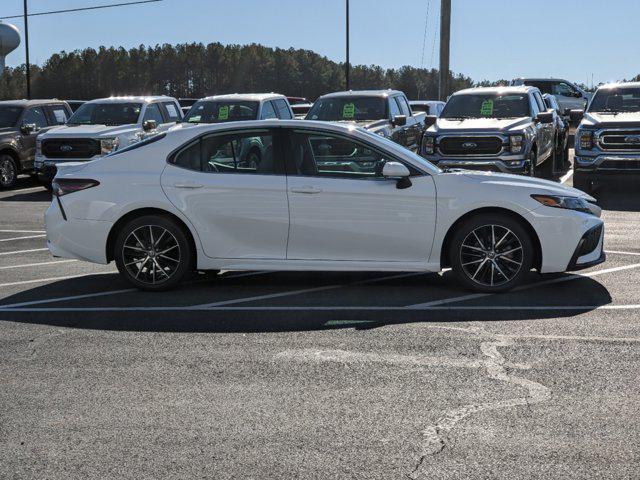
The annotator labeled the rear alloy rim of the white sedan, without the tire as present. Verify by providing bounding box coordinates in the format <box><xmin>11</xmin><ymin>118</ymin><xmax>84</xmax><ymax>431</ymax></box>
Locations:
<box><xmin>122</xmin><ymin>225</ymin><xmax>182</xmax><ymax>285</ymax></box>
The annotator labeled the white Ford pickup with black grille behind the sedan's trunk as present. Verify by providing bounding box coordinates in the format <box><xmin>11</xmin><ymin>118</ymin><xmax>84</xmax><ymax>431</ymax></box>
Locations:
<box><xmin>35</xmin><ymin>96</ymin><xmax>182</xmax><ymax>188</ymax></box>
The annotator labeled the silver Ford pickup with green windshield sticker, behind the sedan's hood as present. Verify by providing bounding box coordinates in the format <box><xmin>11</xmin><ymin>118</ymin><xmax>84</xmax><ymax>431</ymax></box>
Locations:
<box><xmin>420</xmin><ymin>86</ymin><xmax>558</xmax><ymax>177</ymax></box>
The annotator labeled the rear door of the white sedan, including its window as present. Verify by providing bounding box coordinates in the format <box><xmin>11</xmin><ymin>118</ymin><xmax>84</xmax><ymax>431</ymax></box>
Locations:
<box><xmin>161</xmin><ymin>129</ymin><xmax>289</xmax><ymax>260</ymax></box>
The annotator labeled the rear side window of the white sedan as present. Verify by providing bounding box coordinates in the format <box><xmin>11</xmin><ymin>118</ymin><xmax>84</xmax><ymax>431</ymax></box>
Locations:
<box><xmin>169</xmin><ymin>130</ymin><xmax>284</xmax><ymax>175</ymax></box>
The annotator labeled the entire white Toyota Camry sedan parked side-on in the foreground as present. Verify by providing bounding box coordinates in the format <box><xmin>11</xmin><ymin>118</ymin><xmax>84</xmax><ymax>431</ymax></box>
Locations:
<box><xmin>46</xmin><ymin>120</ymin><xmax>605</xmax><ymax>292</ymax></box>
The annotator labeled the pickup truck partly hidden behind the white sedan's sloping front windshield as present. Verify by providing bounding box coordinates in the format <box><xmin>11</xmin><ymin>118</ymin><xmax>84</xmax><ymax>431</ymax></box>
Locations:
<box><xmin>305</xmin><ymin>90</ymin><xmax>426</xmax><ymax>152</ymax></box>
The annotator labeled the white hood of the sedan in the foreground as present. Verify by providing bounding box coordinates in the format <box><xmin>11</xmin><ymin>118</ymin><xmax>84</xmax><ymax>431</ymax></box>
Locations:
<box><xmin>444</xmin><ymin>170</ymin><xmax>596</xmax><ymax>203</ymax></box>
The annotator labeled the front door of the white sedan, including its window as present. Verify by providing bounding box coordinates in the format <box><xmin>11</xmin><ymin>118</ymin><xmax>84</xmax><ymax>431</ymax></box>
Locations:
<box><xmin>286</xmin><ymin>129</ymin><xmax>436</xmax><ymax>262</ymax></box>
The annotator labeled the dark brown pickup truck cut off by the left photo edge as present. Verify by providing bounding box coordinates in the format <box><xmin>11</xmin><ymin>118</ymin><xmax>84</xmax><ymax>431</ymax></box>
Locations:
<box><xmin>0</xmin><ymin>99</ymin><xmax>71</xmax><ymax>188</ymax></box>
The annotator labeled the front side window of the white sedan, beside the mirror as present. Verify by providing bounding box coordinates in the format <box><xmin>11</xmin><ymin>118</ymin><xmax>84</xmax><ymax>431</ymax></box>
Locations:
<box><xmin>287</xmin><ymin>130</ymin><xmax>410</xmax><ymax>180</ymax></box>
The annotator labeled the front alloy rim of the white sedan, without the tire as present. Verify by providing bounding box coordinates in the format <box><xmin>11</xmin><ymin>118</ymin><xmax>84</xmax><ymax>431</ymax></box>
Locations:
<box><xmin>460</xmin><ymin>224</ymin><xmax>524</xmax><ymax>287</ymax></box>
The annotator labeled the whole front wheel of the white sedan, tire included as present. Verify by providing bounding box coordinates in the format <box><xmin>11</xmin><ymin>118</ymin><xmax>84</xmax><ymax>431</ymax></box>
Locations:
<box><xmin>449</xmin><ymin>213</ymin><xmax>534</xmax><ymax>293</ymax></box>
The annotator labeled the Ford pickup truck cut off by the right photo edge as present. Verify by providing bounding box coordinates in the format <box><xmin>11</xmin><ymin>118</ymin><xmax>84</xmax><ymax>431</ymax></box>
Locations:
<box><xmin>571</xmin><ymin>82</ymin><xmax>640</xmax><ymax>193</ymax></box>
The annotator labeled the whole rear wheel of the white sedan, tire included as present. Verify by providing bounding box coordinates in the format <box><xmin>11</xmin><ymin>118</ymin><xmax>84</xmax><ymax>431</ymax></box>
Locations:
<box><xmin>113</xmin><ymin>215</ymin><xmax>194</xmax><ymax>292</ymax></box>
